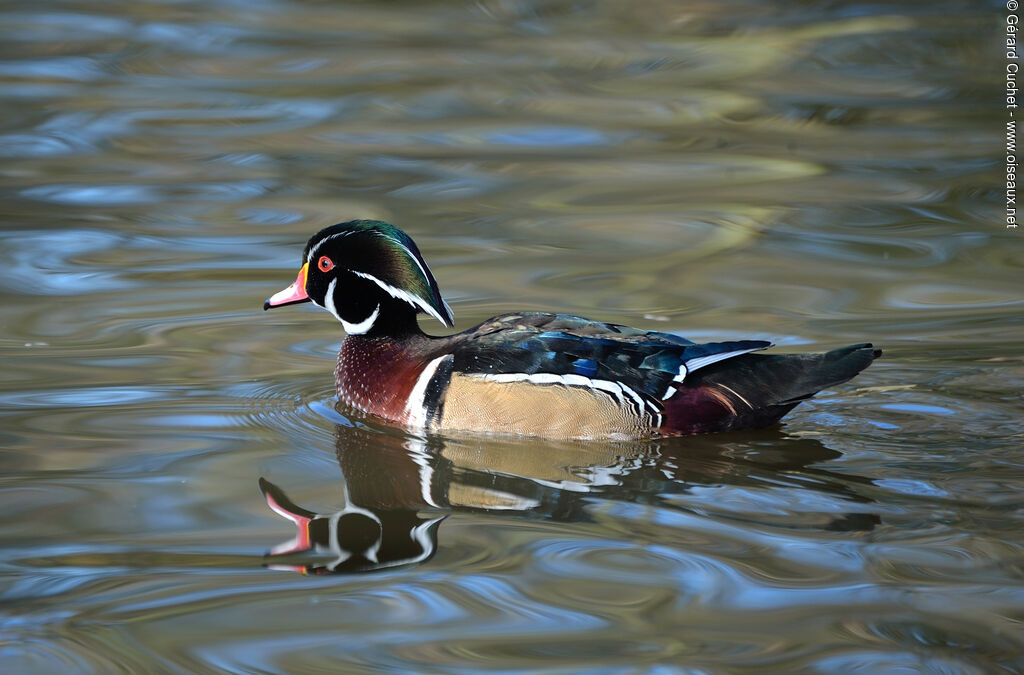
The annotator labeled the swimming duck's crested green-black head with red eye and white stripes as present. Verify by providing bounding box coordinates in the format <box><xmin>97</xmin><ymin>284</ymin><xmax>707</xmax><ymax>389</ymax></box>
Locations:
<box><xmin>263</xmin><ymin>220</ymin><xmax>455</xmax><ymax>335</ymax></box>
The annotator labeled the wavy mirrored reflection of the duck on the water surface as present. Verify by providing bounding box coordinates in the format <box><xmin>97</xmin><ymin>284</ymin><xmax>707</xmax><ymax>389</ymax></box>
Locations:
<box><xmin>259</xmin><ymin>425</ymin><xmax>880</xmax><ymax>574</ymax></box>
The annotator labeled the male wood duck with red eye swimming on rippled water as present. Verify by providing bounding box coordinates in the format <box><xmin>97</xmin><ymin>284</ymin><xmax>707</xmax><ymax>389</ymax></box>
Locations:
<box><xmin>263</xmin><ymin>220</ymin><xmax>882</xmax><ymax>438</ymax></box>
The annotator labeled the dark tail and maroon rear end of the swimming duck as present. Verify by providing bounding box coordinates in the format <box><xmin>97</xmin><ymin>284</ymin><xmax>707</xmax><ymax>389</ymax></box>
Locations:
<box><xmin>663</xmin><ymin>342</ymin><xmax>882</xmax><ymax>434</ymax></box>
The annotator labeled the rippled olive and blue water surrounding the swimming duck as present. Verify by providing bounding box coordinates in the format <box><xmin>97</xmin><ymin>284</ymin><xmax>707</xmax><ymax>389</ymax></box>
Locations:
<box><xmin>0</xmin><ymin>0</ymin><xmax>1024</xmax><ymax>673</ymax></box>
